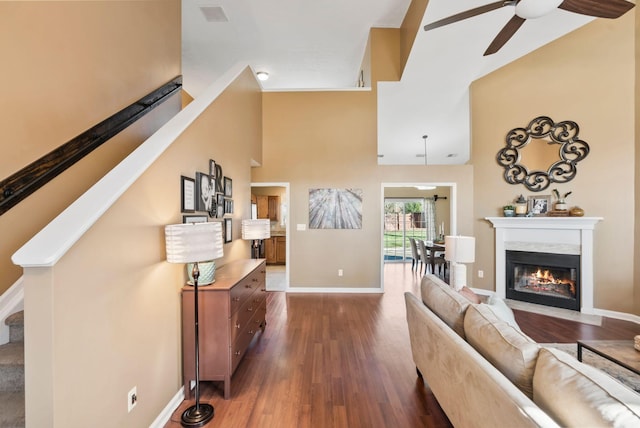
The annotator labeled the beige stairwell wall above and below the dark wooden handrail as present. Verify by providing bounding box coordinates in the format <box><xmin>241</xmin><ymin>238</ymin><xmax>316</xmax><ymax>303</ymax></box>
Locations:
<box><xmin>0</xmin><ymin>0</ymin><xmax>181</xmax><ymax>294</ymax></box>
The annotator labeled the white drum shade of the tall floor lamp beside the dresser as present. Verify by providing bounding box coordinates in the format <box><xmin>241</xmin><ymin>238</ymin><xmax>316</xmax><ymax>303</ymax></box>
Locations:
<box><xmin>164</xmin><ymin>222</ymin><xmax>224</xmax><ymax>263</ymax></box>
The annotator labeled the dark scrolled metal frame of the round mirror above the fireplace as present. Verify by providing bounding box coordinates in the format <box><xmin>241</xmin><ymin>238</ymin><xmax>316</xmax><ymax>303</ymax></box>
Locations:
<box><xmin>496</xmin><ymin>116</ymin><xmax>589</xmax><ymax>192</ymax></box>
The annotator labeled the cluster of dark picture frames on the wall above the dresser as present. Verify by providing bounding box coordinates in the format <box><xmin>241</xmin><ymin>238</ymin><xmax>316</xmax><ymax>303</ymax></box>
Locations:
<box><xmin>180</xmin><ymin>159</ymin><xmax>233</xmax><ymax>243</ymax></box>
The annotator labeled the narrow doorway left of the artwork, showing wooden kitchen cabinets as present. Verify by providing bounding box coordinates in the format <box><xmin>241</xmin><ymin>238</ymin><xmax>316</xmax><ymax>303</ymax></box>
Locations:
<box><xmin>251</xmin><ymin>183</ymin><xmax>291</xmax><ymax>291</ymax></box>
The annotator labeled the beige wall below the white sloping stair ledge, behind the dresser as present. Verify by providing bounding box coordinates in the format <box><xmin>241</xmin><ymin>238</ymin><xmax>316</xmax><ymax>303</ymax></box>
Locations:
<box><xmin>25</xmin><ymin>68</ymin><xmax>261</xmax><ymax>428</ymax></box>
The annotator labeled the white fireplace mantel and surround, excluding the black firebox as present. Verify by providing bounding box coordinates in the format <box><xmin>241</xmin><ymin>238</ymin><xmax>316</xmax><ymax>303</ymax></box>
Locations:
<box><xmin>485</xmin><ymin>217</ymin><xmax>602</xmax><ymax>314</ymax></box>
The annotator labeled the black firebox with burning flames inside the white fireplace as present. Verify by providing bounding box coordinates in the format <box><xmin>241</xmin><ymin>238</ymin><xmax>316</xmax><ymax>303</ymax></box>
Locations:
<box><xmin>505</xmin><ymin>251</ymin><xmax>580</xmax><ymax>311</ymax></box>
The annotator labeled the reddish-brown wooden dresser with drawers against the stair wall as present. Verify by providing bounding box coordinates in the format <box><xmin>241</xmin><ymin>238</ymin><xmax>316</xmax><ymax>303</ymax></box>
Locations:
<box><xmin>182</xmin><ymin>259</ymin><xmax>267</xmax><ymax>399</ymax></box>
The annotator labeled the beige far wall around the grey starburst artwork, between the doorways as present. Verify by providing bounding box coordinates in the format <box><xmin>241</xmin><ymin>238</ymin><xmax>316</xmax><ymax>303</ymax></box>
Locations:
<box><xmin>252</xmin><ymin>29</ymin><xmax>473</xmax><ymax>288</ymax></box>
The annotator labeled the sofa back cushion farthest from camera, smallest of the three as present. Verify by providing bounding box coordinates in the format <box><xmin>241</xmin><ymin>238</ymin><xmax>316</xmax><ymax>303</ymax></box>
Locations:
<box><xmin>420</xmin><ymin>274</ymin><xmax>471</xmax><ymax>339</ymax></box>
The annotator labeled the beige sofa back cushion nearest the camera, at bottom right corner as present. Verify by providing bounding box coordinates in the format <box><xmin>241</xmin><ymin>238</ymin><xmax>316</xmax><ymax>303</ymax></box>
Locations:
<box><xmin>533</xmin><ymin>348</ymin><xmax>640</xmax><ymax>427</ymax></box>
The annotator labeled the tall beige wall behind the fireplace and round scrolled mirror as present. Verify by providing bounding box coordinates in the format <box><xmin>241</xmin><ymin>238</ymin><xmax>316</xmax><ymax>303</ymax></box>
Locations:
<box><xmin>471</xmin><ymin>14</ymin><xmax>640</xmax><ymax>314</ymax></box>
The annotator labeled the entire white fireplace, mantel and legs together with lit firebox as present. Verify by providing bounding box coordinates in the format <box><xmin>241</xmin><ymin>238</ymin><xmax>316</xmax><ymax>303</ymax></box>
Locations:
<box><xmin>486</xmin><ymin>217</ymin><xmax>602</xmax><ymax>313</ymax></box>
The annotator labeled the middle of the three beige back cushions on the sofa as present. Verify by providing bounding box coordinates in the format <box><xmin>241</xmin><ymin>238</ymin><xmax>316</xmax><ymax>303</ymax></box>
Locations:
<box><xmin>464</xmin><ymin>304</ymin><xmax>540</xmax><ymax>398</ymax></box>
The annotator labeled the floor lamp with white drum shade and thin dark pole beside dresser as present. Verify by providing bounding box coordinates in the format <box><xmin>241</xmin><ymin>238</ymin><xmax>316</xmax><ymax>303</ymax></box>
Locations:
<box><xmin>164</xmin><ymin>222</ymin><xmax>223</xmax><ymax>427</ymax></box>
